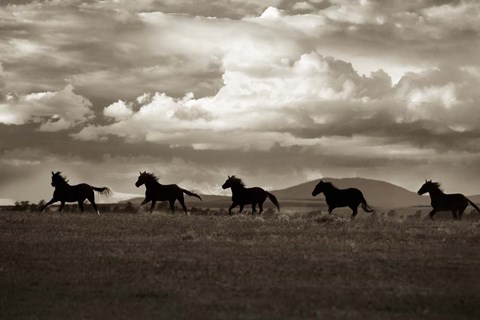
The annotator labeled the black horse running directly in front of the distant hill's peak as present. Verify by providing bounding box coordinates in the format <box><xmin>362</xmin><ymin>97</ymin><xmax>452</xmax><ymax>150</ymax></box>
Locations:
<box><xmin>312</xmin><ymin>180</ymin><xmax>375</xmax><ymax>219</ymax></box>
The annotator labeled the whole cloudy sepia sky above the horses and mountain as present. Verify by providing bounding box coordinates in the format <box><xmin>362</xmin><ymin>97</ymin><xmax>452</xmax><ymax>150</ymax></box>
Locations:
<box><xmin>0</xmin><ymin>0</ymin><xmax>480</xmax><ymax>203</ymax></box>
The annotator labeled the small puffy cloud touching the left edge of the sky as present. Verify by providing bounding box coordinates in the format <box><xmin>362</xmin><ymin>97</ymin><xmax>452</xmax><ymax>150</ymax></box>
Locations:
<box><xmin>0</xmin><ymin>85</ymin><xmax>93</xmax><ymax>131</ymax></box>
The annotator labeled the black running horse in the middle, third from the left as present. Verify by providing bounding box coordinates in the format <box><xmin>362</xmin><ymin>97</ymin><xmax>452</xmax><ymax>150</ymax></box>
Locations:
<box><xmin>222</xmin><ymin>176</ymin><xmax>280</xmax><ymax>215</ymax></box>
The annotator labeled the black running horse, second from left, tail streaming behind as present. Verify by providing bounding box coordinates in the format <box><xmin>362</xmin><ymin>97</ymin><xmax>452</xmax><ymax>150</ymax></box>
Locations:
<box><xmin>135</xmin><ymin>171</ymin><xmax>202</xmax><ymax>214</ymax></box>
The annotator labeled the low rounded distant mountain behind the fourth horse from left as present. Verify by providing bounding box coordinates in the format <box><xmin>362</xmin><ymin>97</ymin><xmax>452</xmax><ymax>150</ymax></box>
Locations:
<box><xmin>272</xmin><ymin>178</ymin><xmax>430</xmax><ymax>208</ymax></box>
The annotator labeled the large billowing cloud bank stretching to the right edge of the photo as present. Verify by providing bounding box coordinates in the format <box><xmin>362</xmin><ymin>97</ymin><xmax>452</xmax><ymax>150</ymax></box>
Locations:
<box><xmin>73</xmin><ymin>48</ymin><xmax>480</xmax><ymax>156</ymax></box>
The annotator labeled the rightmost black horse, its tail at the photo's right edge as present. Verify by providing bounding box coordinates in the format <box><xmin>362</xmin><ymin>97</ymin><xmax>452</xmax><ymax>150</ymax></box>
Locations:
<box><xmin>417</xmin><ymin>180</ymin><xmax>480</xmax><ymax>220</ymax></box>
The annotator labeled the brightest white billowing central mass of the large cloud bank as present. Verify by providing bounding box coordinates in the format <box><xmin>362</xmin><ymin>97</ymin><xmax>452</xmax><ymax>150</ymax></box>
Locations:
<box><xmin>70</xmin><ymin>52</ymin><xmax>391</xmax><ymax>150</ymax></box>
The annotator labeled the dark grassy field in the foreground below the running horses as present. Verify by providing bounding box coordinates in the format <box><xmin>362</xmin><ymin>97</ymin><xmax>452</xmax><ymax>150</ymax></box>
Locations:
<box><xmin>0</xmin><ymin>212</ymin><xmax>480</xmax><ymax>319</ymax></box>
